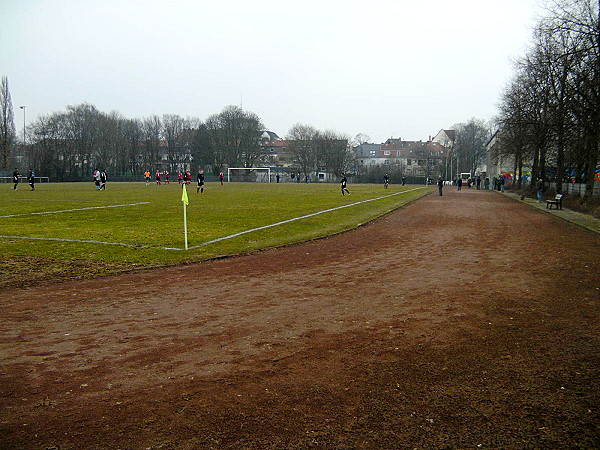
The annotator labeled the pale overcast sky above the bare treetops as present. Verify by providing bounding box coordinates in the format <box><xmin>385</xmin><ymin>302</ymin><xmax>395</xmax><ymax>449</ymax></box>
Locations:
<box><xmin>0</xmin><ymin>0</ymin><xmax>542</xmax><ymax>143</ymax></box>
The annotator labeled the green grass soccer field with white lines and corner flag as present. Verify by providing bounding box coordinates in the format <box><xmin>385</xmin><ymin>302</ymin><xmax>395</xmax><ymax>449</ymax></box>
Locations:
<box><xmin>0</xmin><ymin>183</ymin><xmax>431</xmax><ymax>272</ymax></box>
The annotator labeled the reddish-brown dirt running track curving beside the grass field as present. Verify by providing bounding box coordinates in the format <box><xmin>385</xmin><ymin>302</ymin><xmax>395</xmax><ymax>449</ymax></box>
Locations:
<box><xmin>0</xmin><ymin>188</ymin><xmax>600</xmax><ymax>449</ymax></box>
